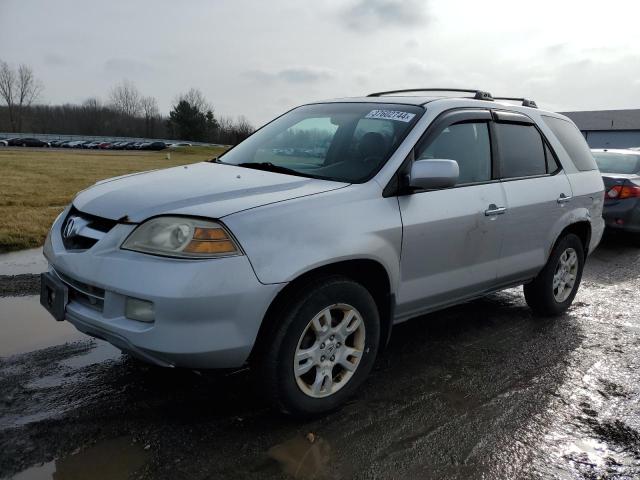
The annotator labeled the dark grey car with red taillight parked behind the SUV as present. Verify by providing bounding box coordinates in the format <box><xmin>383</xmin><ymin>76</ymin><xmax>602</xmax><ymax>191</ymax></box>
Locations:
<box><xmin>591</xmin><ymin>149</ymin><xmax>640</xmax><ymax>233</ymax></box>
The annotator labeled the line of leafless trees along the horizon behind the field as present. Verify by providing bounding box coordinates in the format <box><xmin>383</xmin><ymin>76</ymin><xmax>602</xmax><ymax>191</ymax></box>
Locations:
<box><xmin>0</xmin><ymin>60</ymin><xmax>254</xmax><ymax>145</ymax></box>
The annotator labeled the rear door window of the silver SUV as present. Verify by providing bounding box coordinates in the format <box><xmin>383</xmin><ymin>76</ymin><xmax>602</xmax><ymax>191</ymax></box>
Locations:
<box><xmin>495</xmin><ymin>123</ymin><xmax>547</xmax><ymax>178</ymax></box>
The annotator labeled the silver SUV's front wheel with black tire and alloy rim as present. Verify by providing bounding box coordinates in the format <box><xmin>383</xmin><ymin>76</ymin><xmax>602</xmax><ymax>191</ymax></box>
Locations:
<box><xmin>256</xmin><ymin>276</ymin><xmax>380</xmax><ymax>416</ymax></box>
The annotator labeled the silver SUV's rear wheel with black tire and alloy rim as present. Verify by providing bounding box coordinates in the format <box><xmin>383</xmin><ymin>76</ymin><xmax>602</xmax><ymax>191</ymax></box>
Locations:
<box><xmin>524</xmin><ymin>233</ymin><xmax>584</xmax><ymax>316</ymax></box>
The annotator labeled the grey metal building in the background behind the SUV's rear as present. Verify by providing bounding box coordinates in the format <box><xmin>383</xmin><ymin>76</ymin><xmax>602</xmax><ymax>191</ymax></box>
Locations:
<box><xmin>562</xmin><ymin>109</ymin><xmax>640</xmax><ymax>148</ymax></box>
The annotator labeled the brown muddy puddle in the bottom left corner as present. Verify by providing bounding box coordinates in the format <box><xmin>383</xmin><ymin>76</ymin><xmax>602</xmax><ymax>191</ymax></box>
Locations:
<box><xmin>9</xmin><ymin>437</ymin><xmax>149</xmax><ymax>480</ymax></box>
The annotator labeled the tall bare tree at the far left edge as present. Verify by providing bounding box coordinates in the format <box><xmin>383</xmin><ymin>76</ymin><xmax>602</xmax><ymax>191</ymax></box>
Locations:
<box><xmin>0</xmin><ymin>62</ymin><xmax>43</xmax><ymax>132</ymax></box>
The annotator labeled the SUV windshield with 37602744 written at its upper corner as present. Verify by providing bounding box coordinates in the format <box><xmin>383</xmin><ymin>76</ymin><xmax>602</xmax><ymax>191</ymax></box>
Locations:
<box><xmin>219</xmin><ymin>103</ymin><xmax>424</xmax><ymax>183</ymax></box>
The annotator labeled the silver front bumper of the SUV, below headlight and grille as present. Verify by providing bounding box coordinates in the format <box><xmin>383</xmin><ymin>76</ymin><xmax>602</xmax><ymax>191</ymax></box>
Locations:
<box><xmin>44</xmin><ymin>210</ymin><xmax>282</xmax><ymax>368</ymax></box>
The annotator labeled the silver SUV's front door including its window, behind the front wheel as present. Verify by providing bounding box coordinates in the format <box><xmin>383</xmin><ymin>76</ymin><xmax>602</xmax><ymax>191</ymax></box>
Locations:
<box><xmin>396</xmin><ymin>110</ymin><xmax>505</xmax><ymax>318</ymax></box>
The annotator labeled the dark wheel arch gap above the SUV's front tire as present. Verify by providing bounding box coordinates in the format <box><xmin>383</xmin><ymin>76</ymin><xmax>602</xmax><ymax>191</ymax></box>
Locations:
<box><xmin>249</xmin><ymin>259</ymin><xmax>395</xmax><ymax>361</ymax></box>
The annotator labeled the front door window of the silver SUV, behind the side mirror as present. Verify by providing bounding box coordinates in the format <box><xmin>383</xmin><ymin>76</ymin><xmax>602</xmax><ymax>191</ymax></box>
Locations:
<box><xmin>416</xmin><ymin>122</ymin><xmax>491</xmax><ymax>184</ymax></box>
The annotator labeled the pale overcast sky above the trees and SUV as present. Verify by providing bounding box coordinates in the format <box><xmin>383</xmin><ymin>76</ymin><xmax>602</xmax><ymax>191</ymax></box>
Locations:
<box><xmin>0</xmin><ymin>0</ymin><xmax>640</xmax><ymax>126</ymax></box>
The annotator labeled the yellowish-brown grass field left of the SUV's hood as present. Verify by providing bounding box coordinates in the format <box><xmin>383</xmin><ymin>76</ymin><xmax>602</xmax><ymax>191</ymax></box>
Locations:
<box><xmin>0</xmin><ymin>147</ymin><xmax>229</xmax><ymax>252</ymax></box>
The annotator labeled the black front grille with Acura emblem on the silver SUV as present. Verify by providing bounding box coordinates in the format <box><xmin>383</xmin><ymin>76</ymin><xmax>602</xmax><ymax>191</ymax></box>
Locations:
<box><xmin>60</xmin><ymin>206</ymin><xmax>118</xmax><ymax>250</ymax></box>
